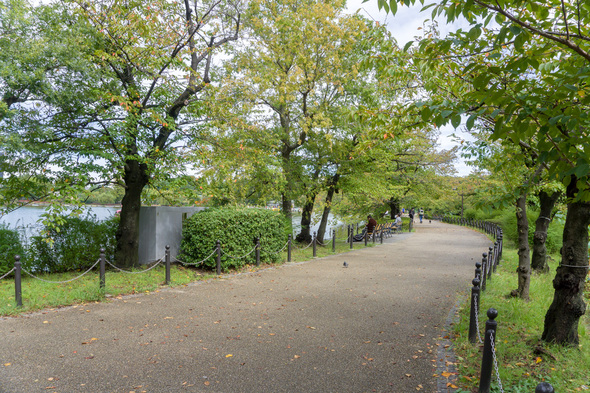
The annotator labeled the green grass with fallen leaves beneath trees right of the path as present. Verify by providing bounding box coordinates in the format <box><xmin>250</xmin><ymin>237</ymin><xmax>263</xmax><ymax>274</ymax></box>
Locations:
<box><xmin>453</xmin><ymin>249</ymin><xmax>590</xmax><ymax>393</ymax></box>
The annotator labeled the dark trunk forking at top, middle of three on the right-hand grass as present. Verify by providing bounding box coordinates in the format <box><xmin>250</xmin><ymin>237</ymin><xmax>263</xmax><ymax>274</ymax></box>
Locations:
<box><xmin>531</xmin><ymin>191</ymin><xmax>561</xmax><ymax>273</ymax></box>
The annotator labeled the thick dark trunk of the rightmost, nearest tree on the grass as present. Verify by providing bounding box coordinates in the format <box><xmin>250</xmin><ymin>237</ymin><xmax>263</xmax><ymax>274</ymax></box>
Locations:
<box><xmin>541</xmin><ymin>176</ymin><xmax>590</xmax><ymax>346</ymax></box>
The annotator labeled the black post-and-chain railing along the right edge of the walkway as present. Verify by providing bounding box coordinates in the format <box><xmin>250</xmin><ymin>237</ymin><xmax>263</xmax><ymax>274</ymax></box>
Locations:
<box><xmin>448</xmin><ymin>217</ymin><xmax>554</xmax><ymax>393</ymax></box>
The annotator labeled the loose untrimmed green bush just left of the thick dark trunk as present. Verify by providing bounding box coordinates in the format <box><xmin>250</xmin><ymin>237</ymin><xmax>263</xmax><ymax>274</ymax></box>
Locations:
<box><xmin>23</xmin><ymin>216</ymin><xmax>119</xmax><ymax>273</ymax></box>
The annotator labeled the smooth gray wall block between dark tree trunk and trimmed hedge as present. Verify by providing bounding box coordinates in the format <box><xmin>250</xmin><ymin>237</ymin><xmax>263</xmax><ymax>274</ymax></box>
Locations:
<box><xmin>139</xmin><ymin>206</ymin><xmax>206</xmax><ymax>264</ymax></box>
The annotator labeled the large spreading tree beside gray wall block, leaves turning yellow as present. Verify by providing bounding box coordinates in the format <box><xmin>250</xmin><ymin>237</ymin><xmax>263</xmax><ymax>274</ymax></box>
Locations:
<box><xmin>3</xmin><ymin>0</ymin><xmax>241</xmax><ymax>266</ymax></box>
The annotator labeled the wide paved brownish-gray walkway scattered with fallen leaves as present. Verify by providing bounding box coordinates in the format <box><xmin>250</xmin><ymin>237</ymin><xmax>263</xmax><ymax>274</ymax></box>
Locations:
<box><xmin>0</xmin><ymin>221</ymin><xmax>490</xmax><ymax>393</ymax></box>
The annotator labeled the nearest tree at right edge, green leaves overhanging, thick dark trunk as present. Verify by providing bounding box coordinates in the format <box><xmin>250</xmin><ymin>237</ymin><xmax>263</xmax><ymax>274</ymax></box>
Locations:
<box><xmin>379</xmin><ymin>0</ymin><xmax>590</xmax><ymax>345</ymax></box>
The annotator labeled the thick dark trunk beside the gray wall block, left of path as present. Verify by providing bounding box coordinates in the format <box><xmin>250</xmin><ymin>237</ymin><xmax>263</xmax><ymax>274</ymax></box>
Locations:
<box><xmin>115</xmin><ymin>160</ymin><xmax>148</xmax><ymax>267</ymax></box>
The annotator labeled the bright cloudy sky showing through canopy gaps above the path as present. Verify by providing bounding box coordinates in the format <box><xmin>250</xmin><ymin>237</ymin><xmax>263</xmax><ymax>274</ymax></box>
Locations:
<box><xmin>347</xmin><ymin>0</ymin><xmax>471</xmax><ymax>176</ymax></box>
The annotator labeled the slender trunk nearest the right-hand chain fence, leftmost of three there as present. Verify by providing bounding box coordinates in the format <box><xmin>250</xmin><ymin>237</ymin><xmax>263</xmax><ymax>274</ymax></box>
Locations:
<box><xmin>512</xmin><ymin>194</ymin><xmax>531</xmax><ymax>300</ymax></box>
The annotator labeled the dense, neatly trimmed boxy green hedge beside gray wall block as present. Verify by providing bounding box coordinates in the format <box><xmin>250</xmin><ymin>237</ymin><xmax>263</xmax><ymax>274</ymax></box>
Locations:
<box><xmin>179</xmin><ymin>208</ymin><xmax>286</xmax><ymax>271</ymax></box>
